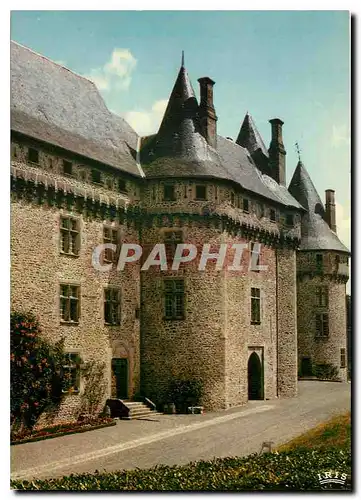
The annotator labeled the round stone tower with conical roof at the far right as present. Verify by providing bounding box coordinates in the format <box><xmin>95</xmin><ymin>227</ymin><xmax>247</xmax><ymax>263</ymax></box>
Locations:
<box><xmin>289</xmin><ymin>161</ymin><xmax>350</xmax><ymax>381</ymax></box>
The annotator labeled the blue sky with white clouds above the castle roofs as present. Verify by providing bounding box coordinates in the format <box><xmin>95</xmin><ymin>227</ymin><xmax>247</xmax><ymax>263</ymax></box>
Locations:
<box><xmin>11</xmin><ymin>11</ymin><xmax>350</xmax><ymax>256</ymax></box>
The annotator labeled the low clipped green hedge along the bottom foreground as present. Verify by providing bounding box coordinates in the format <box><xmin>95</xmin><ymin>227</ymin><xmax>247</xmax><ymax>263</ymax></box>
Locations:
<box><xmin>11</xmin><ymin>447</ymin><xmax>351</xmax><ymax>491</ymax></box>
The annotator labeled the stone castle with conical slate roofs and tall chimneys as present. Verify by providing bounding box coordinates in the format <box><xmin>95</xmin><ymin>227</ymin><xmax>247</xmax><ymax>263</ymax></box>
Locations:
<box><xmin>11</xmin><ymin>42</ymin><xmax>350</xmax><ymax>418</ymax></box>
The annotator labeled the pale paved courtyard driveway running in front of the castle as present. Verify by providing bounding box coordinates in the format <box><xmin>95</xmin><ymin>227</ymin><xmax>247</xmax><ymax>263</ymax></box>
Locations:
<box><xmin>11</xmin><ymin>381</ymin><xmax>351</xmax><ymax>479</ymax></box>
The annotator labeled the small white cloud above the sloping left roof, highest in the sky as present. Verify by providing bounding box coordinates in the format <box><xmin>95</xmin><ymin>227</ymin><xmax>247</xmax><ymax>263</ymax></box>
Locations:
<box><xmin>84</xmin><ymin>48</ymin><xmax>137</xmax><ymax>91</ymax></box>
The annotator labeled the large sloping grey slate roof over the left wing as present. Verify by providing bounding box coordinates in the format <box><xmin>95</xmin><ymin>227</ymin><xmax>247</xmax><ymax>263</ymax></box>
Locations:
<box><xmin>11</xmin><ymin>42</ymin><xmax>140</xmax><ymax>176</ymax></box>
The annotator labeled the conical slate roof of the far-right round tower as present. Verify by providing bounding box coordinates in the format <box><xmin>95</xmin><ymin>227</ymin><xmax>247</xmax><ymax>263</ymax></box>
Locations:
<box><xmin>288</xmin><ymin>161</ymin><xmax>349</xmax><ymax>253</ymax></box>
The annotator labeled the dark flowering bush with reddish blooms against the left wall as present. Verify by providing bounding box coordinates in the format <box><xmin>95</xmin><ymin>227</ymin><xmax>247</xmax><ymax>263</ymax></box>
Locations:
<box><xmin>10</xmin><ymin>312</ymin><xmax>64</xmax><ymax>429</ymax></box>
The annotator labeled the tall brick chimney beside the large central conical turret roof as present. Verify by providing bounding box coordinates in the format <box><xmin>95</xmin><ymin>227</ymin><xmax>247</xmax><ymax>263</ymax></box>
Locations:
<box><xmin>198</xmin><ymin>76</ymin><xmax>217</xmax><ymax>149</ymax></box>
